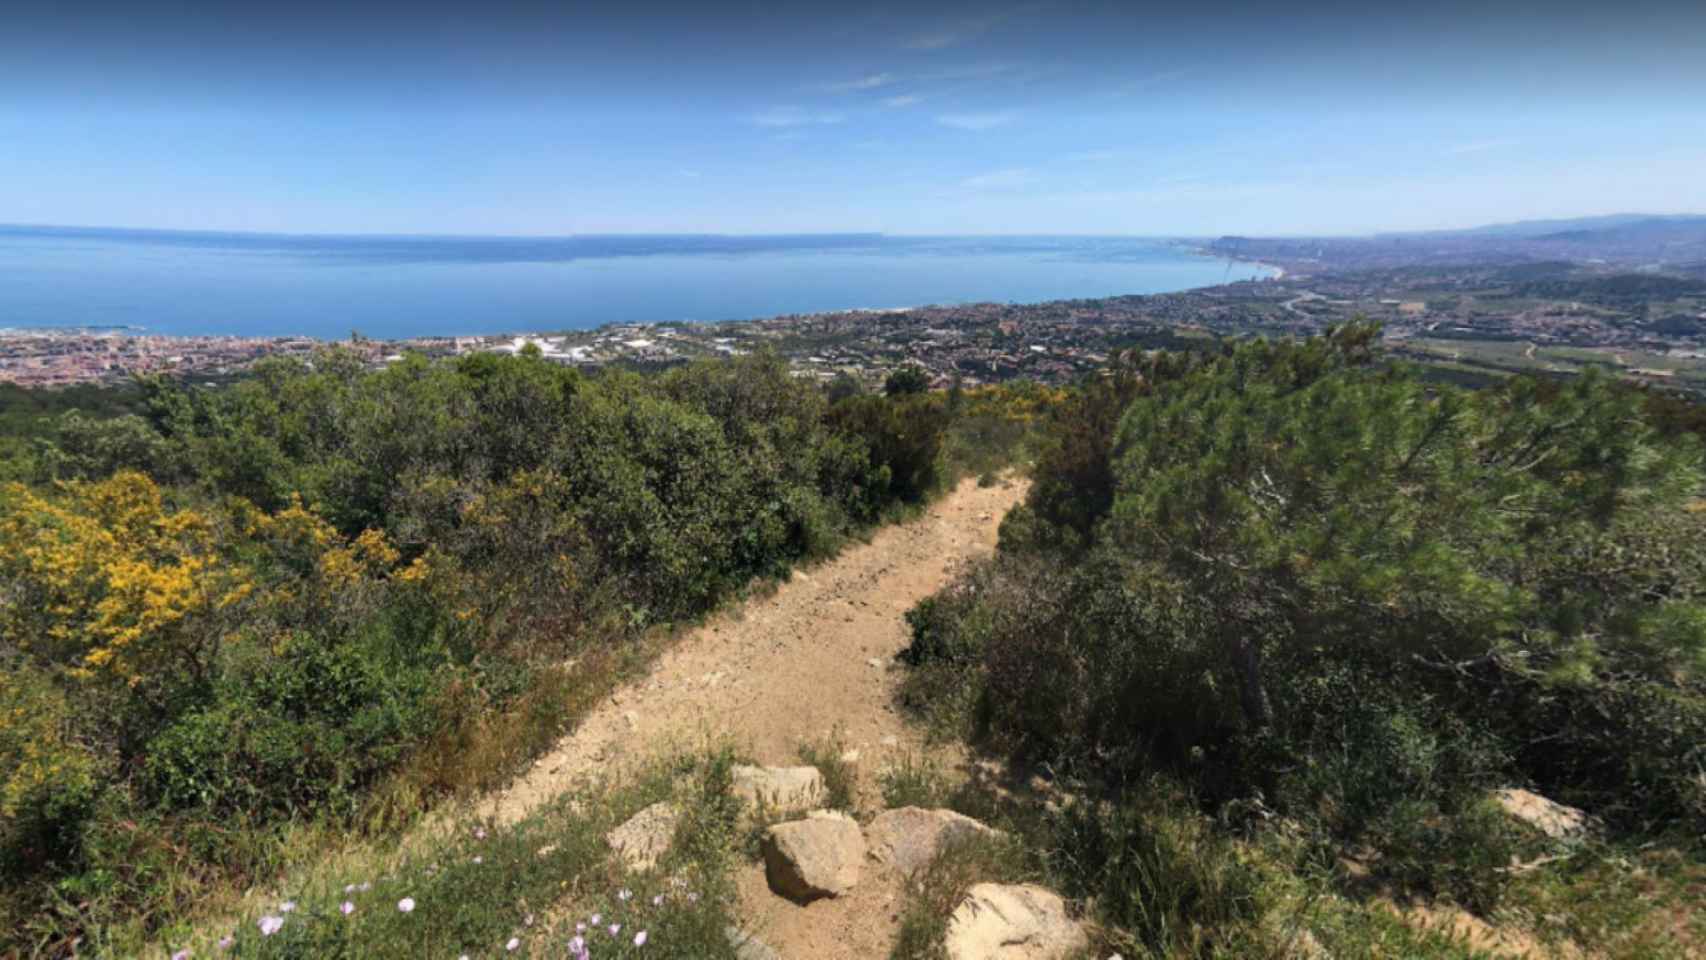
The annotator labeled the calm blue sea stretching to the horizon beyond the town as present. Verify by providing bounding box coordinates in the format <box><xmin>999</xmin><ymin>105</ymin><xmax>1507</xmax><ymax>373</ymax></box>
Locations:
<box><xmin>0</xmin><ymin>227</ymin><xmax>1271</xmax><ymax>339</ymax></box>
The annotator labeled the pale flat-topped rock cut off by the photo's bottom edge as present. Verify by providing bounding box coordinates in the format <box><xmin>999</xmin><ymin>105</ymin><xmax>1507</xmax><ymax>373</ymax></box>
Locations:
<box><xmin>943</xmin><ymin>883</ymin><xmax>1088</xmax><ymax>960</ymax></box>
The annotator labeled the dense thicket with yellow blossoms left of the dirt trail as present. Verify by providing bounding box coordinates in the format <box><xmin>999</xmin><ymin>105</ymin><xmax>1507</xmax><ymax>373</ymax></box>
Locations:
<box><xmin>0</xmin><ymin>350</ymin><xmax>1054</xmax><ymax>951</ymax></box>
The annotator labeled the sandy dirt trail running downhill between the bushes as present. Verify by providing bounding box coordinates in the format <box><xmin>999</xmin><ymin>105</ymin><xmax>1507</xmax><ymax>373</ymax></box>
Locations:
<box><xmin>479</xmin><ymin>481</ymin><xmax>1024</xmax><ymax>960</ymax></box>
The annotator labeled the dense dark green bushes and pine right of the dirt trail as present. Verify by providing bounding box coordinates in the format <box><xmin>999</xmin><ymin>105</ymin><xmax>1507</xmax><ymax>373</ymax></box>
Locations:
<box><xmin>908</xmin><ymin>326</ymin><xmax>1706</xmax><ymax>955</ymax></box>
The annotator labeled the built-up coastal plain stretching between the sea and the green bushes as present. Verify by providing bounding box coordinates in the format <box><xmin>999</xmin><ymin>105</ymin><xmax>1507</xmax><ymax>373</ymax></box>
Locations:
<box><xmin>0</xmin><ymin>264</ymin><xmax>1706</xmax><ymax>387</ymax></box>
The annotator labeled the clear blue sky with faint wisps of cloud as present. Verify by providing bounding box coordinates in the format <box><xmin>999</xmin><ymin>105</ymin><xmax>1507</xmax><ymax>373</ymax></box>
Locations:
<box><xmin>0</xmin><ymin>0</ymin><xmax>1706</xmax><ymax>235</ymax></box>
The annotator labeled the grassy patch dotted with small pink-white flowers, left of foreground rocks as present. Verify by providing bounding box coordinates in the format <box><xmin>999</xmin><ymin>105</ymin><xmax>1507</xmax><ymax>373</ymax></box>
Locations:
<box><xmin>194</xmin><ymin>750</ymin><xmax>737</xmax><ymax>958</ymax></box>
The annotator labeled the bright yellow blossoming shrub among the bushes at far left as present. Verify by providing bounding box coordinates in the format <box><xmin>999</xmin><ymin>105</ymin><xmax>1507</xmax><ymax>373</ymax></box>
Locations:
<box><xmin>0</xmin><ymin>472</ymin><xmax>412</xmax><ymax>687</ymax></box>
